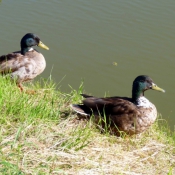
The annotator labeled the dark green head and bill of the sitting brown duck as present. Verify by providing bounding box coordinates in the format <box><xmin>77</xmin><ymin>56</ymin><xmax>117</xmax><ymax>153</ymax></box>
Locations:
<box><xmin>132</xmin><ymin>75</ymin><xmax>165</xmax><ymax>103</ymax></box>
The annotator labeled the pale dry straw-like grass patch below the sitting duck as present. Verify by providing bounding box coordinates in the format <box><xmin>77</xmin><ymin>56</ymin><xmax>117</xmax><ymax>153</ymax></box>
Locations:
<box><xmin>0</xmin><ymin>118</ymin><xmax>175</xmax><ymax>175</ymax></box>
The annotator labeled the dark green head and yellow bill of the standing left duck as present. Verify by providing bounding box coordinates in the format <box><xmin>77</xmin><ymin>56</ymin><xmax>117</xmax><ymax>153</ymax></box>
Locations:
<box><xmin>21</xmin><ymin>33</ymin><xmax>49</xmax><ymax>55</ymax></box>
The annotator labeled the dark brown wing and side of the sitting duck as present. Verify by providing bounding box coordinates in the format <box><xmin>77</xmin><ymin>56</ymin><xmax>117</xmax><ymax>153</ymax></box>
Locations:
<box><xmin>79</xmin><ymin>96</ymin><xmax>142</xmax><ymax>134</ymax></box>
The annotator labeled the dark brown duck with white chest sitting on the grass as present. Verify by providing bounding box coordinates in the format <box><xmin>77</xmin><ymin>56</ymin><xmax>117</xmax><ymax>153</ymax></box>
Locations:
<box><xmin>71</xmin><ymin>75</ymin><xmax>165</xmax><ymax>135</ymax></box>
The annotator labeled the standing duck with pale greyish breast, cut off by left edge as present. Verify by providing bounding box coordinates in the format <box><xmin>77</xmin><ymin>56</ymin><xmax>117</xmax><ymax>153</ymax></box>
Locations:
<box><xmin>0</xmin><ymin>33</ymin><xmax>49</xmax><ymax>91</ymax></box>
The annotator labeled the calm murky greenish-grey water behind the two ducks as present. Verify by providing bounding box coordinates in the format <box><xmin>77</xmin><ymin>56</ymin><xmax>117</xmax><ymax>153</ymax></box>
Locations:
<box><xmin>0</xmin><ymin>0</ymin><xmax>175</xmax><ymax>128</ymax></box>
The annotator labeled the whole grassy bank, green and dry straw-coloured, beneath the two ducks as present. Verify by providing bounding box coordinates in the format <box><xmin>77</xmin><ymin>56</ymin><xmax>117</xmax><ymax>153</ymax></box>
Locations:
<box><xmin>0</xmin><ymin>77</ymin><xmax>175</xmax><ymax>175</ymax></box>
